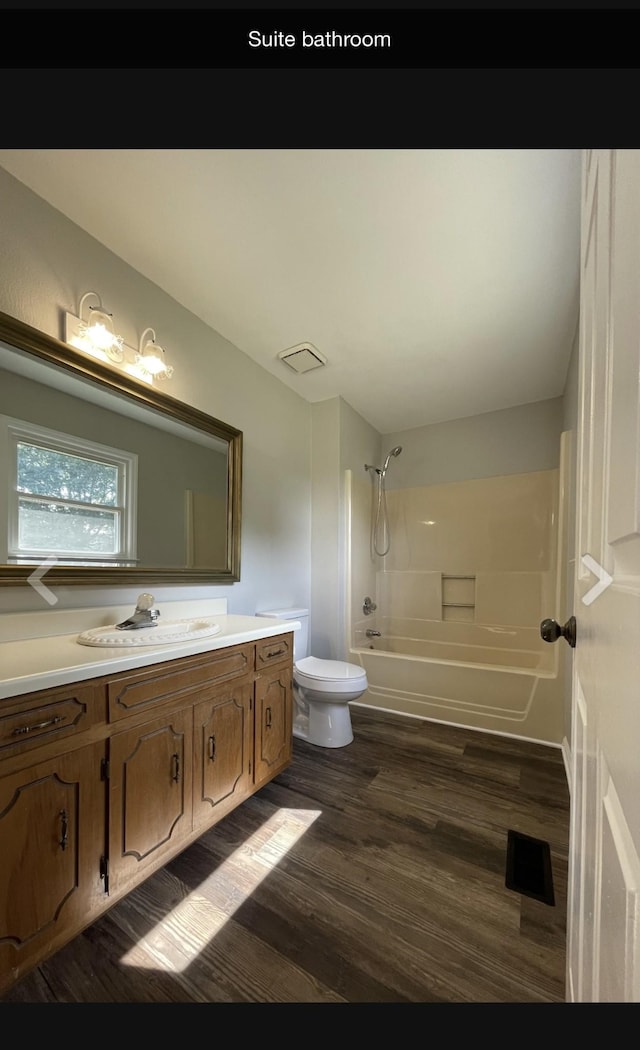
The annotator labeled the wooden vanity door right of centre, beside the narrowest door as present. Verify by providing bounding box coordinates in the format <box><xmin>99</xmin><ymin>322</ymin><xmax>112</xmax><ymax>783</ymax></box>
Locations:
<box><xmin>193</xmin><ymin>683</ymin><xmax>253</xmax><ymax>826</ymax></box>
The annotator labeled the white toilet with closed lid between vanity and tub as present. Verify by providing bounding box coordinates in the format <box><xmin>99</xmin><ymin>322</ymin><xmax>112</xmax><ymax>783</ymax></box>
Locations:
<box><xmin>256</xmin><ymin>609</ymin><xmax>368</xmax><ymax>748</ymax></box>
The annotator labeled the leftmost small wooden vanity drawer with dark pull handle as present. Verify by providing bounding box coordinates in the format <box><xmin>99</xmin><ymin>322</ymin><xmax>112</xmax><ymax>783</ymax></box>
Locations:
<box><xmin>0</xmin><ymin>684</ymin><xmax>106</xmax><ymax>758</ymax></box>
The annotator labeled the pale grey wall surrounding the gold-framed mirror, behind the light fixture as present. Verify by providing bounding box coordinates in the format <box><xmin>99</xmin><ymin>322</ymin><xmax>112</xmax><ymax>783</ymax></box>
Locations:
<box><xmin>0</xmin><ymin>170</ymin><xmax>312</xmax><ymax>613</ymax></box>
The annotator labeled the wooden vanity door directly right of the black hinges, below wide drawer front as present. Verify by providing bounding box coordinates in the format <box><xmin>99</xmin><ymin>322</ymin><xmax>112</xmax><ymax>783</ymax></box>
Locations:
<box><xmin>109</xmin><ymin>709</ymin><xmax>193</xmax><ymax>893</ymax></box>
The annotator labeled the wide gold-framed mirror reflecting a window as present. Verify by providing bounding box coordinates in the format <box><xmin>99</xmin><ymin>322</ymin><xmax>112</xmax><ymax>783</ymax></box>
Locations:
<box><xmin>0</xmin><ymin>312</ymin><xmax>242</xmax><ymax>586</ymax></box>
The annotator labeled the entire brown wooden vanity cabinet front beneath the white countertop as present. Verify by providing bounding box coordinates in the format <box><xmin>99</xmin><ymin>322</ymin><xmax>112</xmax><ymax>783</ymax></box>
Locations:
<box><xmin>0</xmin><ymin>634</ymin><xmax>293</xmax><ymax>994</ymax></box>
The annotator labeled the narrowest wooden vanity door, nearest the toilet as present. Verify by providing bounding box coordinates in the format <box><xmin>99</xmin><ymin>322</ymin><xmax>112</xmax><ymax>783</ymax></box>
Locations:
<box><xmin>254</xmin><ymin>665</ymin><xmax>293</xmax><ymax>784</ymax></box>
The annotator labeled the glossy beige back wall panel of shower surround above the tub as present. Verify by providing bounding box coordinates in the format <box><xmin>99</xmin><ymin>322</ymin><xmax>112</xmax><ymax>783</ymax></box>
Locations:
<box><xmin>378</xmin><ymin>470</ymin><xmax>558</xmax><ymax>628</ymax></box>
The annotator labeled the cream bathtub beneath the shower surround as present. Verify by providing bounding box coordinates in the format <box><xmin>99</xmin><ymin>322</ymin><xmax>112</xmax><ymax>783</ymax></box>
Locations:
<box><xmin>348</xmin><ymin>618</ymin><xmax>563</xmax><ymax>746</ymax></box>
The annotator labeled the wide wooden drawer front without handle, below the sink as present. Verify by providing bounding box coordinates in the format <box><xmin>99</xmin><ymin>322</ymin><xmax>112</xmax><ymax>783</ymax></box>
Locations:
<box><xmin>107</xmin><ymin>645</ymin><xmax>253</xmax><ymax>722</ymax></box>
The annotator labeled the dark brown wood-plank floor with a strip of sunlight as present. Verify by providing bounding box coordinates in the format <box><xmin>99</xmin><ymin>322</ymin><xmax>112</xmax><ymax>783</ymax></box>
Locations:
<box><xmin>2</xmin><ymin>706</ymin><xmax>569</xmax><ymax>1003</ymax></box>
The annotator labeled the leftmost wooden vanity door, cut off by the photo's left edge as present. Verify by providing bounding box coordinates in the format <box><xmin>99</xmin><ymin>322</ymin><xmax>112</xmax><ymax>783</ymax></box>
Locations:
<box><xmin>0</xmin><ymin>743</ymin><xmax>105</xmax><ymax>989</ymax></box>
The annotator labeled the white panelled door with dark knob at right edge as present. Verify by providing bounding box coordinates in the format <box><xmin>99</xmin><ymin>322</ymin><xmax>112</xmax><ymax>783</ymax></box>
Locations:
<box><xmin>567</xmin><ymin>149</ymin><xmax>640</xmax><ymax>1003</ymax></box>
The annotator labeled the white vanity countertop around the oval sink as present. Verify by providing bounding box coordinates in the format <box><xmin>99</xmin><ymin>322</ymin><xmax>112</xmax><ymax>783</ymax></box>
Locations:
<box><xmin>0</xmin><ymin>610</ymin><xmax>301</xmax><ymax>699</ymax></box>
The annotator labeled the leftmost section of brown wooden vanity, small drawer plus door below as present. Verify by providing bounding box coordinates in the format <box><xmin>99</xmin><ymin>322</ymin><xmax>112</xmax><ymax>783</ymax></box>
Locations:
<box><xmin>0</xmin><ymin>681</ymin><xmax>106</xmax><ymax>991</ymax></box>
